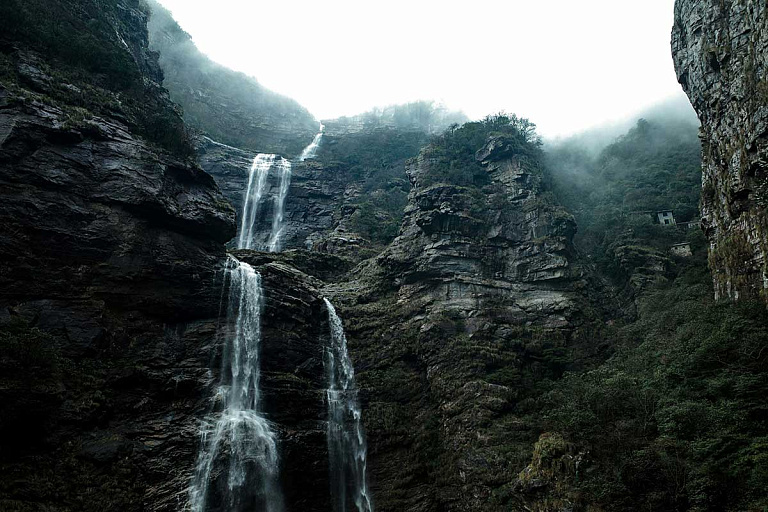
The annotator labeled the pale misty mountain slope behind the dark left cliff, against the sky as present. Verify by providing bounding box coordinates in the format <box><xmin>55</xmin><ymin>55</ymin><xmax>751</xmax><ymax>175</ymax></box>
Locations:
<box><xmin>149</xmin><ymin>1</ymin><xmax>319</xmax><ymax>157</ymax></box>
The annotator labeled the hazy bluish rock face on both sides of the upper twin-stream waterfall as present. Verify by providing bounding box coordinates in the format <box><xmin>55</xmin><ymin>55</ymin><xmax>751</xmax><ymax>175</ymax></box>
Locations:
<box><xmin>196</xmin><ymin>129</ymin><xmax>427</xmax><ymax>261</ymax></box>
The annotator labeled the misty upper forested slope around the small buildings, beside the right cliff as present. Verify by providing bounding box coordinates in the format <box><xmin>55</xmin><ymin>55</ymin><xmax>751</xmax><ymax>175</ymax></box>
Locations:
<box><xmin>546</xmin><ymin>119</ymin><xmax>705</xmax><ymax>282</ymax></box>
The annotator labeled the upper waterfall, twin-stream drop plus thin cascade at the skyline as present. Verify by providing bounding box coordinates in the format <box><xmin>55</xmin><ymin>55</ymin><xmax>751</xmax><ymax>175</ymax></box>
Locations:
<box><xmin>237</xmin><ymin>124</ymin><xmax>325</xmax><ymax>252</ymax></box>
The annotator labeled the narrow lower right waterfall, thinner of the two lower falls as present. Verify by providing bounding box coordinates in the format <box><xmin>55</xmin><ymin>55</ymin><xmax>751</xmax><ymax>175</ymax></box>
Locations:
<box><xmin>323</xmin><ymin>299</ymin><xmax>373</xmax><ymax>512</ymax></box>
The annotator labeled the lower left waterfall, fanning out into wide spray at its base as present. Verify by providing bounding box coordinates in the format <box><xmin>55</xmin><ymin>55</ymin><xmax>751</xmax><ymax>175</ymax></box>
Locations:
<box><xmin>189</xmin><ymin>257</ymin><xmax>283</xmax><ymax>512</ymax></box>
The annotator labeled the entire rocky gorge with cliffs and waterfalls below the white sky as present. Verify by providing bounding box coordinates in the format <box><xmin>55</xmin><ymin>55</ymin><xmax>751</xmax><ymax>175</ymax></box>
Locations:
<box><xmin>0</xmin><ymin>0</ymin><xmax>768</xmax><ymax>512</ymax></box>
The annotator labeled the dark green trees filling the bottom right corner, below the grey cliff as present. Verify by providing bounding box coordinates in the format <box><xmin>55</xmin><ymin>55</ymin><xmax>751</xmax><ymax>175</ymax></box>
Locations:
<box><xmin>541</xmin><ymin>267</ymin><xmax>768</xmax><ymax>511</ymax></box>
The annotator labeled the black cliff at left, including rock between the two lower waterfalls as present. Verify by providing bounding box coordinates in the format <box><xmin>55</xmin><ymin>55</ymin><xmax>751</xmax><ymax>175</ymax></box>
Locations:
<box><xmin>0</xmin><ymin>0</ymin><xmax>330</xmax><ymax>511</ymax></box>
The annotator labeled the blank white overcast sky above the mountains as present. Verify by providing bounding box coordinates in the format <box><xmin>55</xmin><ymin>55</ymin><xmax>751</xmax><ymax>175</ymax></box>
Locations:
<box><xmin>154</xmin><ymin>0</ymin><xmax>681</xmax><ymax>137</ymax></box>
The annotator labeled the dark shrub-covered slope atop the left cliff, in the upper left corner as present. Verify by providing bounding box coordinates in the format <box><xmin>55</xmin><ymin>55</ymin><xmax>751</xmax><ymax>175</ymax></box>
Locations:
<box><xmin>0</xmin><ymin>0</ymin><xmax>193</xmax><ymax>157</ymax></box>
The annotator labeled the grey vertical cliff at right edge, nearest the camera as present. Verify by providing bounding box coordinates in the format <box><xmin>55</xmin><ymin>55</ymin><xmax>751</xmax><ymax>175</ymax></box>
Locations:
<box><xmin>672</xmin><ymin>0</ymin><xmax>768</xmax><ymax>299</ymax></box>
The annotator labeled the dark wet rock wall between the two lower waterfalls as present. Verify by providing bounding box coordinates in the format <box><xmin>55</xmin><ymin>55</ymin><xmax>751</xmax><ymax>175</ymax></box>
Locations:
<box><xmin>192</xmin><ymin>251</ymin><xmax>331</xmax><ymax>512</ymax></box>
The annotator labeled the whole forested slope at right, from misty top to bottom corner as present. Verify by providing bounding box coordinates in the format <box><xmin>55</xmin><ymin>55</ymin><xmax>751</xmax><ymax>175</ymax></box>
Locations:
<box><xmin>524</xmin><ymin>120</ymin><xmax>768</xmax><ymax>511</ymax></box>
